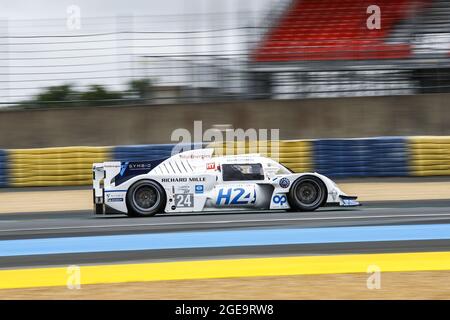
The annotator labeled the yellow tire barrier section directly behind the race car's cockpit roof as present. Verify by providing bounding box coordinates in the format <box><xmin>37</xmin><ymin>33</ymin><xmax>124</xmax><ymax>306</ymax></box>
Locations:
<box><xmin>207</xmin><ymin>140</ymin><xmax>313</xmax><ymax>172</ymax></box>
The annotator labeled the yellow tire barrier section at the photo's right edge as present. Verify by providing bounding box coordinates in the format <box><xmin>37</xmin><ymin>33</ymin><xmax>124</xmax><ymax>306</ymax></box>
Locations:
<box><xmin>408</xmin><ymin>136</ymin><xmax>450</xmax><ymax>176</ymax></box>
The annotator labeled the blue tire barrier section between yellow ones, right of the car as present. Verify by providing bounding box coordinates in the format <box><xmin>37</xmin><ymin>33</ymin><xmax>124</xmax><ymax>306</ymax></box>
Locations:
<box><xmin>313</xmin><ymin>137</ymin><xmax>408</xmax><ymax>177</ymax></box>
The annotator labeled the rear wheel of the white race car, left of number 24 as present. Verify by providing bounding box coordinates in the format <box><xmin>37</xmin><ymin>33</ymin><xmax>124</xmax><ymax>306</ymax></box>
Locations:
<box><xmin>127</xmin><ymin>180</ymin><xmax>166</xmax><ymax>217</ymax></box>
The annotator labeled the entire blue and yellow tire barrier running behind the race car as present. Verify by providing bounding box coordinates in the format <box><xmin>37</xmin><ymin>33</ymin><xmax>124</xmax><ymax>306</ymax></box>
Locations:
<box><xmin>0</xmin><ymin>136</ymin><xmax>450</xmax><ymax>187</ymax></box>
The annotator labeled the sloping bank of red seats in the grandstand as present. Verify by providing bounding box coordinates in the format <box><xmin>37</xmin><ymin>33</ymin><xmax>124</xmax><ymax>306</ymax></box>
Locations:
<box><xmin>253</xmin><ymin>0</ymin><xmax>429</xmax><ymax>62</ymax></box>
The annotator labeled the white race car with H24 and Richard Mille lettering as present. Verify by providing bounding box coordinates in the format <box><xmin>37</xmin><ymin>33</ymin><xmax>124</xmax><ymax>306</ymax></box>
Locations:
<box><xmin>93</xmin><ymin>149</ymin><xmax>359</xmax><ymax>217</ymax></box>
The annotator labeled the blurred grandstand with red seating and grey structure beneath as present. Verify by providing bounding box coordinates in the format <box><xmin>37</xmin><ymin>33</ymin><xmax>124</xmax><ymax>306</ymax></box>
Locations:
<box><xmin>251</xmin><ymin>0</ymin><xmax>450</xmax><ymax>99</ymax></box>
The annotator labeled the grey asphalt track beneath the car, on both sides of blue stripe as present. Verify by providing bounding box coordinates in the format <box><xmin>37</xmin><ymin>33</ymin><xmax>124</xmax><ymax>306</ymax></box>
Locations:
<box><xmin>0</xmin><ymin>200</ymin><xmax>450</xmax><ymax>268</ymax></box>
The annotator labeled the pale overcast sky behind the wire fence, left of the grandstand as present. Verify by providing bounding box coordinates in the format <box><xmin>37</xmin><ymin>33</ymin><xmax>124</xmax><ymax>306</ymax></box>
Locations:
<box><xmin>0</xmin><ymin>0</ymin><xmax>278</xmax><ymax>106</ymax></box>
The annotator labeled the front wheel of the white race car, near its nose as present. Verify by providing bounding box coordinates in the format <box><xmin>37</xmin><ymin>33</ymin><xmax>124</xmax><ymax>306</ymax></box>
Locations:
<box><xmin>288</xmin><ymin>176</ymin><xmax>327</xmax><ymax>211</ymax></box>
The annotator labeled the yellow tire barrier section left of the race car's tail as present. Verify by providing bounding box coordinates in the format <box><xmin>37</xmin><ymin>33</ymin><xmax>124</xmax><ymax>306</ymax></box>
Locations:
<box><xmin>8</xmin><ymin>147</ymin><xmax>111</xmax><ymax>187</ymax></box>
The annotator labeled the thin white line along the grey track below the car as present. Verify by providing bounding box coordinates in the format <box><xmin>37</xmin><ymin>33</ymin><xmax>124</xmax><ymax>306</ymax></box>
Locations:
<box><xmin>0</xmin><ymin>213</ymin><xmax>450</xmax><ymax>233</ymax></box>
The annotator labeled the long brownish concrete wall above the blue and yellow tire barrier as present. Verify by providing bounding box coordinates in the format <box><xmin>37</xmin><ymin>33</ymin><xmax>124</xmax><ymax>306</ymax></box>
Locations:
<box><xmin>0</xmin><ymin>94</ymin><xmax>450</xmax><ymax>148</ymax></box>
